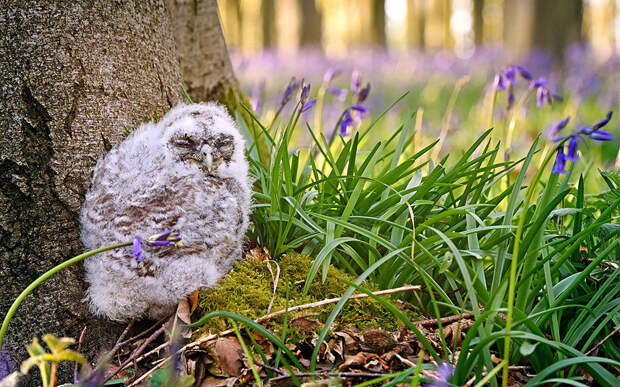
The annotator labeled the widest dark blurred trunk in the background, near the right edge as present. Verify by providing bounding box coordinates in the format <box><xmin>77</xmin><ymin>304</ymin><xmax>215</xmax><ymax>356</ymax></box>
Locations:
<box><xmin>532</xmin><ymin>0</ymin><xmax>583</xmax><ymax>63</ymax></box>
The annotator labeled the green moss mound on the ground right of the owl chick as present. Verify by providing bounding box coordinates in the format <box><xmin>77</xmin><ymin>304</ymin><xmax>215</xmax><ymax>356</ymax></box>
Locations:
<box><xmin>191</xmin><ymin>253</ymin><xmax>412</xmax><ymax>342</ymax></box>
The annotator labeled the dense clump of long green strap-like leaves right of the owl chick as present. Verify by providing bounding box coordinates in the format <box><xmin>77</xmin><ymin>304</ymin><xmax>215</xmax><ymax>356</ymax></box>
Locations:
<box><xmin>214</xmin><ymin>83</ymin><xmax>620</xmax><ymax>386</ymax></box>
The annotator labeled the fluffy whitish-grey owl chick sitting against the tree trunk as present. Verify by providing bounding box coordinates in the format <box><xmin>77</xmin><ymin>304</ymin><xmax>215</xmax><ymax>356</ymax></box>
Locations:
<box><xmin>80</xmin><ymin>103</ymin><xmax>251</xmax><ymax>321</ymax></box>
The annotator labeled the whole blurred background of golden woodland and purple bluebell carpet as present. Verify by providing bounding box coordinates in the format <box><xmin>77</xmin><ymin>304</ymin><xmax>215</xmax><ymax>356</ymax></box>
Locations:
<box><xmin>218</xmin><ymin>0</ymin><xmax>620</xmax><ymax>173</ymax></box>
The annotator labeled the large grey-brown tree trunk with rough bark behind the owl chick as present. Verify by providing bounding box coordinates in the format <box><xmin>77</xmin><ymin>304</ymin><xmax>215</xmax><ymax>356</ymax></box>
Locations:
<box><xmin>0</xmin><ymin>0</ymin><xmax>235</xmax><ymax>385</ymax></box>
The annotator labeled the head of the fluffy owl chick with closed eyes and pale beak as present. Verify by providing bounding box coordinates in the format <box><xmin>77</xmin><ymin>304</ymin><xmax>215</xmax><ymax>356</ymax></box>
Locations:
<box><xmin>160</xmin><ymin>103</ymin><xmax>247</xmax><ymax>177</ymax></box>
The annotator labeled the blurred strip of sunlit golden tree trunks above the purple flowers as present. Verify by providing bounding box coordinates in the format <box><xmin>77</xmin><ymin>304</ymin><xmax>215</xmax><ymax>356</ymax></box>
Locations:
<box><xmin>219</xmin><ymin>0</ymin><xmax>620</xmax><ymax>61</ymax></box>
